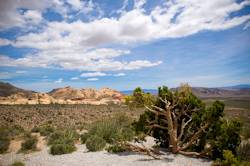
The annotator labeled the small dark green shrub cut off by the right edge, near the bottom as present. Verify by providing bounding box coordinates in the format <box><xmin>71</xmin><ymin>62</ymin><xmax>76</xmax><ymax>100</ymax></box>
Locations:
<box><xmin>237</xmin><ymin>140</ymin><xmax>250</xmax><ymax>161</ymax></box>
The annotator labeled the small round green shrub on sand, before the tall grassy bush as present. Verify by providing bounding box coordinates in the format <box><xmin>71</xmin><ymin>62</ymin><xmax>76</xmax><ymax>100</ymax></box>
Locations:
<box><xmin>86</xmin><ymin>135</ymin><xmax>106</xmax><ymax>152</ymax></box>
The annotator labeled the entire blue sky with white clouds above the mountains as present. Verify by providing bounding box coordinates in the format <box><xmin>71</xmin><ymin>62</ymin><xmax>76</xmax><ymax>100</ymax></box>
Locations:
<box><xmin>0</xmin><ymin>0</ymin><xmax>250</xmax><ymax>91</ymax></box>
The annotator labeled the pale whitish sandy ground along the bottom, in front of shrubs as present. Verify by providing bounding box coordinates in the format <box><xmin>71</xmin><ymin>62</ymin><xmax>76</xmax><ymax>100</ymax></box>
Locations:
<box><xmin>0</xmin><ymin>139</ymin><xmax>211</xmax><ymax>166</ymax></box>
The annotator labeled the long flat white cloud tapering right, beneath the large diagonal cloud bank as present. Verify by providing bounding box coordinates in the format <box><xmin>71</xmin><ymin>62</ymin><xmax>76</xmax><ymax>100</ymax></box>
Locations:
<box><xmin>0</xmin><ymin>48</ymin><xmax>160</xmax><ymax>71</ymax></box>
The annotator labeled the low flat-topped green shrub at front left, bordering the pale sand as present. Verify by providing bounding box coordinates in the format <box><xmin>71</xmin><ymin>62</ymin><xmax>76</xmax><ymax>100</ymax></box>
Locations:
<box><xmin>50</xmin><ymin>143</ymin><xmax>76</xmax><ymax>155</ymax></box>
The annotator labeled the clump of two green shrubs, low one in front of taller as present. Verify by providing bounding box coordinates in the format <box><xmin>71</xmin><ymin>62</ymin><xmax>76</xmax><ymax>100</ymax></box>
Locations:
<box><xmin>48</xmin><ymin>130</ymin><xmax>79</xmax><ymax>155</ymax></box>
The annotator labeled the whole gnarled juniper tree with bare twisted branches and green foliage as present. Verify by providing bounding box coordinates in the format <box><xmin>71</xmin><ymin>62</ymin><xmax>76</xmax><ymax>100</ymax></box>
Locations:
<box><xmin>135</xmin><ymin>85</ymin><xmax>241</xmax><ymax>158</ymax></box>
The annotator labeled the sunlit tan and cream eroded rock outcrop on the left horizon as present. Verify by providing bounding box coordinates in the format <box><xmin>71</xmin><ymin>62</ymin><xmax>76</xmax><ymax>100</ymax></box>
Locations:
<box><xmin>0</xmin><ymin>82</ymin><xmax>124</xmax><ymax>105</ymax></box>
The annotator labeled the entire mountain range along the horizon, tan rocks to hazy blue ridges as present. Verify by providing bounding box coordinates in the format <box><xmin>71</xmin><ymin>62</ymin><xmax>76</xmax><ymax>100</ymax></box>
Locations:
<box><xmin>0</xmin><ymin>82</ymin><xmax>250</xmax><ymax>105</ymax></box>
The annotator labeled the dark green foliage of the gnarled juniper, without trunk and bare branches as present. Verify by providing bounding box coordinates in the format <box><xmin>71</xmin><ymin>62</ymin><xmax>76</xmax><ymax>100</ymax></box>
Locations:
<box><xmin>133</xmin><ymin>85</ymin><xmax>242</xmax><ymax>159</ymax></box>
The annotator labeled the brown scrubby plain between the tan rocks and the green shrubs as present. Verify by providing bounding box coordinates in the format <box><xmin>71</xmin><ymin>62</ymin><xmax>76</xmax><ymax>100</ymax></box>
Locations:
<box><xmin>0</xmin><ymin>104</ymin><xmax>144</xmax><ymax>130</ymax></box>
